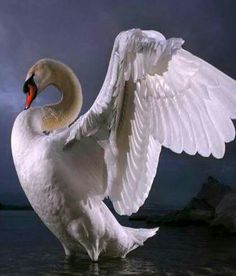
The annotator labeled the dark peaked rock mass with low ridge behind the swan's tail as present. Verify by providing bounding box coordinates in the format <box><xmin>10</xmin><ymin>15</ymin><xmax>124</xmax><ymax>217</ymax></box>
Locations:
<box><xmin>130</xmin><ymin>176</ymin><xmax>236</xmax><ymax>234</ymax></box>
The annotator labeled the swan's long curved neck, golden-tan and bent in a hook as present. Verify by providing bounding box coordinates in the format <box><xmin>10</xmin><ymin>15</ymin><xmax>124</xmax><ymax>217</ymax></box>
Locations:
<box><xmin>42</xmin><ymin>62</ymin><xmax>83</xmax><ymax>131</ymax></box>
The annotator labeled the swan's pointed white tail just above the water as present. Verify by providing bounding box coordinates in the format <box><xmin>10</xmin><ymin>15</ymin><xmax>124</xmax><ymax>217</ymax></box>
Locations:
<box><xmin>122</xmin><ymin>226</ymin><xmax>159</xmax><ymax>257</ymax></box>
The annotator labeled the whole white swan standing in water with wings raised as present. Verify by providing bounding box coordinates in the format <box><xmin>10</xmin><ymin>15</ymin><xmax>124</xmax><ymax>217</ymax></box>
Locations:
<box><xmin>11</xmin><ymin>29</ymin><xmax>236</xmax><ymax>261</ymax></box>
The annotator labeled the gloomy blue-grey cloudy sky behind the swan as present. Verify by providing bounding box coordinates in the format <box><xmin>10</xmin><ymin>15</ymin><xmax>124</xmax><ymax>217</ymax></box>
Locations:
<box><xmin>0</xmin><ymin>0</ymin><xmax>236</xmax><ymax>206</ymax></box>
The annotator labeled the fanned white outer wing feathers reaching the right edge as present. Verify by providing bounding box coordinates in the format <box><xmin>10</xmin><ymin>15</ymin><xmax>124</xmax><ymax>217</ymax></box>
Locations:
<box><xmin>153</xmin><ymin>49</ymin><xmax>236</xmax><ymax>158</ymax></box>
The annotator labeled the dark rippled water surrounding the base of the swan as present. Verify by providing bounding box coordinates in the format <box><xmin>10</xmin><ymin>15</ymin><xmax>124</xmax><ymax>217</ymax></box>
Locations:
<box><xmin>0</xmin><ymin>211</ymin><xmax>236</xmax><ymax>275</ymax></box>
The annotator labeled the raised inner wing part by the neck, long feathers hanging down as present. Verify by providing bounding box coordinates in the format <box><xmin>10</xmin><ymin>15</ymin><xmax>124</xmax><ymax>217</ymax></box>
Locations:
<box><xmin>64</xmin><ymin>30</ymin><xmax>175</xmax><ymax>214</ymax></box>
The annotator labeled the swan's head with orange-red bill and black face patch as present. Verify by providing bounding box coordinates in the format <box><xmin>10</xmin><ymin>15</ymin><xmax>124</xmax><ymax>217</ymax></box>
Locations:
<box><xmin>23</xmin><ymin>59</ymin><xmax>56</xmax><ymax>109</ymax></box>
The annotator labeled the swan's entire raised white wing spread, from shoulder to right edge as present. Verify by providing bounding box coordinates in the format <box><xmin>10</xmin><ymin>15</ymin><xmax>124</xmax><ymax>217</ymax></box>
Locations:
<box><xmin>67</xmin><ymin>29</ymin><xmax>236</xmax><ymax>215</ymax></box>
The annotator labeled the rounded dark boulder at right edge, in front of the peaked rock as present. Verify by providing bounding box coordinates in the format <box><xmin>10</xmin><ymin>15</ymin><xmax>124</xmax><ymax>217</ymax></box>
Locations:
<box><xmin>211</xmin><ymin>192</ymin><xmax>236</xmax><ymax>234</ymax></box>
